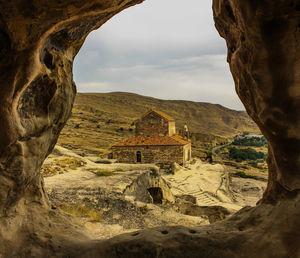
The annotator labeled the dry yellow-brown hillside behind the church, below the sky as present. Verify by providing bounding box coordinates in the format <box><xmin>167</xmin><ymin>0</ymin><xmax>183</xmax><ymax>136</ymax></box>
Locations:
<box><xmin>59</xmin><ymin>92</ymin><xmax>258</xmax><ymax>153</ymax></box>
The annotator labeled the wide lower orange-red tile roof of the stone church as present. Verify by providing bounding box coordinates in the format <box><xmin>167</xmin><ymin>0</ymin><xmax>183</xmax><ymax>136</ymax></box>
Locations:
<box><xmin>112</xmin><ymin>135</ymin><xmax>189</xmax><ymax>147</ymax></box>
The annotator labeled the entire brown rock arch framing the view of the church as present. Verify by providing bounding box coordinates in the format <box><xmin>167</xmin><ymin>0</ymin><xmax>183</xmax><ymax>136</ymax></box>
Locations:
<box><xmin>0</xmin><ymin>0</ymin><xmax>300</xmax><ymax>257</ymax></box>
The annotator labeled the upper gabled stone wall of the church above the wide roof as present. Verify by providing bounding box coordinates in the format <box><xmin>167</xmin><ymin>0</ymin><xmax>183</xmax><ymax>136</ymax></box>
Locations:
<box><xmin>135</xmin><ymin>113</ymin><xmax>169</xmax><ymax>136</ymax></box>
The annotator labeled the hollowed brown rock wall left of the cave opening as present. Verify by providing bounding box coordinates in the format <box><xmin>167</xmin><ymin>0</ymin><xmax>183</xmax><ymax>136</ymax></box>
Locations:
<box><xmin>0</xmin><ymin>0</ymin><xmax>141</xmax><ymax>216</ymax></box>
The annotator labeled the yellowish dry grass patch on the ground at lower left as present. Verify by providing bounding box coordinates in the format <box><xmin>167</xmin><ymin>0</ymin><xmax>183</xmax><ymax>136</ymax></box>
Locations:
<box><xmin>60</xmin><ymin>204</ymin><xmax>103</xmax><ymax>222</ymax></box>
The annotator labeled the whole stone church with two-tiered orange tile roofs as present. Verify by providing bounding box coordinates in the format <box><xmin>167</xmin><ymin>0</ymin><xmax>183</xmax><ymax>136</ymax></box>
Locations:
<box><xmin>112</xmin><ymin>110</ymin><xmax>191</xmax><ymax>167</ymax></box>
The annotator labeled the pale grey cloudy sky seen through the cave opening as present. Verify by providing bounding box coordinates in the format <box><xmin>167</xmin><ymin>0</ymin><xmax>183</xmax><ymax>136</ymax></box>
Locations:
<box><xmin>74</xmin><ymin>0</ymin><xmax>244</xmax><ymax>110</ymax></box>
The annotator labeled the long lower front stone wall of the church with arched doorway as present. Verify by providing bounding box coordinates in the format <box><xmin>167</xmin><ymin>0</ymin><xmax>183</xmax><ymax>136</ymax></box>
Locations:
<box><xmin>112</xmin><ymin>146</ymin><xmax>184</xmax><ymax>164</ymax></box>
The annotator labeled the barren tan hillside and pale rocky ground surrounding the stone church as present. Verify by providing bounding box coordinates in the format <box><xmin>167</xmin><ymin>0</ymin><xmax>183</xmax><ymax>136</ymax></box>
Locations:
<box><xmin>36</xmin><ymin>93</ymin><xmax>267</xmax><ymax>239</ymax></box>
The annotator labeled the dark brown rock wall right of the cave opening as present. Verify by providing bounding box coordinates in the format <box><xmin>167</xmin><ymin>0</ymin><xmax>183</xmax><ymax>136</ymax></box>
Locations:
<box><xmin>213</xmin><ymin>0</ymin><xmax>300</xmax><ymax>201</ymax></box>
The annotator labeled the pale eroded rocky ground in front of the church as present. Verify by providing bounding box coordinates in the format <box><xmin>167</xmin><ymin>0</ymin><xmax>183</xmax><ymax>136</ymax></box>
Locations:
<box><xmin>42</xmin><ymin>146</ymin><xmax>266</xmax><ymax>239</ymax></box>
